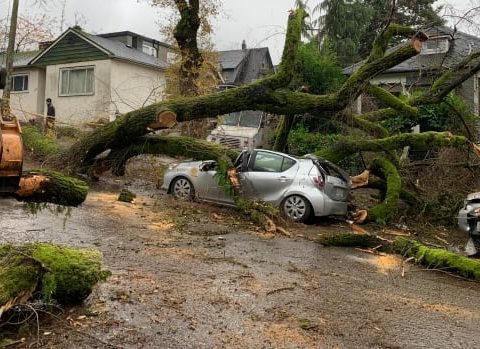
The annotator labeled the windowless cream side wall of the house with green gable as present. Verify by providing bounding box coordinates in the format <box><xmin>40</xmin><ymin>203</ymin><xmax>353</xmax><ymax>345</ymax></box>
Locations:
<box><xmin>111</xmin><ymin>60</ymin><xmax>166</xmax><ymax>115</ymax></box>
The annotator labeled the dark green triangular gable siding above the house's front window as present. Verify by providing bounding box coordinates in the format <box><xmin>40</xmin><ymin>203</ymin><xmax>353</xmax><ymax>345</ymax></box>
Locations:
<box><xmin>35</xmin><ymin>32</ymin><xmax>108</xmax><ymax>66</ymax></box>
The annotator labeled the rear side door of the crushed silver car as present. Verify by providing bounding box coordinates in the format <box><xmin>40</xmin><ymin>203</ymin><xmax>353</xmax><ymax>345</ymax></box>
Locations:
<box><xmin>240</xmin><ymin>150</ymin><xmax>299</xmax><ymax>203</ymax></box>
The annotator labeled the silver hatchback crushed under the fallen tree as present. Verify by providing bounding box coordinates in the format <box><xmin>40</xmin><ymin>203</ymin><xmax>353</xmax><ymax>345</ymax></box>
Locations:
<box><xmin>162</xmin><ymin>149</ymin><xmax>351</xmax><ymax>221</ymax></box>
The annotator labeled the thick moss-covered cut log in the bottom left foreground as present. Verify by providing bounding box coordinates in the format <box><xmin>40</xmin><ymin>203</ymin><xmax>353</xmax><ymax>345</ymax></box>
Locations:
<box><xmin>0</xmin><ymin>243</ymin><xmax>110</xmax><ymax>318</ymax></box>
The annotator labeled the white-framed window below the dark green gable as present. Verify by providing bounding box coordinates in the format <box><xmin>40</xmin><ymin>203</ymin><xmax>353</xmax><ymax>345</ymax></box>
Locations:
<box><xmin>60</xmin><ymin>67</ymin><xmax>94</xmax><ymax>96</ymax></box>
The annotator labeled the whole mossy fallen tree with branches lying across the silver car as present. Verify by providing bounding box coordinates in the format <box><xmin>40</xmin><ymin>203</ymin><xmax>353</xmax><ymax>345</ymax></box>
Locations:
<box><xmin>38</xmin><ymin>10</ymin><xmax>480</xmax><ymax>222</ymax></box>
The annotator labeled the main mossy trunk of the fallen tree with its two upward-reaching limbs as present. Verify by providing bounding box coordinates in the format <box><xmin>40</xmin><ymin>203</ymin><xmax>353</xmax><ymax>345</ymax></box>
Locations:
<box><xmin>62</xmin><ymin>11</ymin><xmax>420</xmax><ymax>173</ymax></box>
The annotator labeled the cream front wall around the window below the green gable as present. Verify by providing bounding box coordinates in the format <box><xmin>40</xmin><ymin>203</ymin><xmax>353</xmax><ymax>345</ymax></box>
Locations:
<box><xmin>45</xmin><ymin>60</ymin><xmax>112</xmax><ymax>126</ymax></box>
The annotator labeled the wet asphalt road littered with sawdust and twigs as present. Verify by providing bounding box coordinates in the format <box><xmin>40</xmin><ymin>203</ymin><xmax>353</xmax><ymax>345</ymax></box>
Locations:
<box><xmin>0</xmin><ymin>191</ymin><xmax>480</xmax><ymax>348</ymax></box>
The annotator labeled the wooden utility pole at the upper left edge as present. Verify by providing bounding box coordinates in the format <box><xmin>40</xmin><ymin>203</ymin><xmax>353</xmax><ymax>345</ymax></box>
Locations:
<box><xmin>1</xmin><ymin>0</ymin><xmax>19</xmax><ymax>120</ymax></box>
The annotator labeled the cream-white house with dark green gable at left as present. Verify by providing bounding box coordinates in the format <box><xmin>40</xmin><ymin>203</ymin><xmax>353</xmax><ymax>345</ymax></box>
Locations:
<box><xmin>0</xmin><ymin>28</ymin><xmax>173</xmax><ymax>126</ymax></box>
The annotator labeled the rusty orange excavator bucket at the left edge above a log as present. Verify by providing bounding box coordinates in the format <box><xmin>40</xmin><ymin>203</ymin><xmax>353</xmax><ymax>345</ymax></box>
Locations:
<box><xmin>0</xmin><ymin>118</ymin><xmax>23</xmax><ymax>193</ymax></box>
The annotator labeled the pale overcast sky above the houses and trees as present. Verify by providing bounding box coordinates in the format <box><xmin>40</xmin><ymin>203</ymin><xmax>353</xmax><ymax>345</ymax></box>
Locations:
<box><xmin>0</xmin><ymin>0</ymin><xmax>474</xmax><ymax>64</ymax></box>
